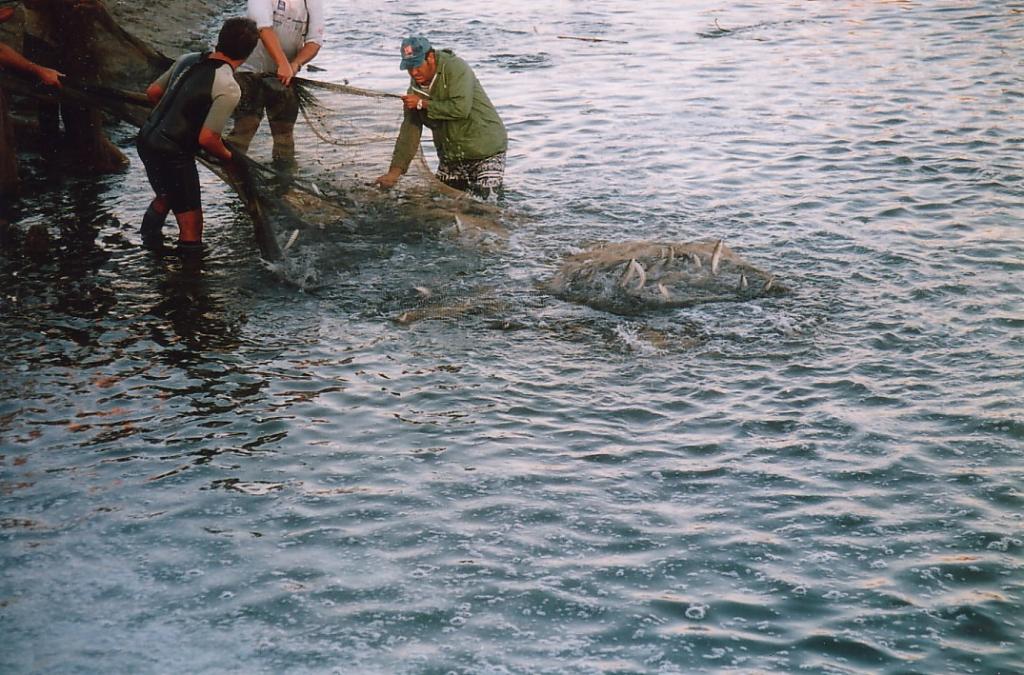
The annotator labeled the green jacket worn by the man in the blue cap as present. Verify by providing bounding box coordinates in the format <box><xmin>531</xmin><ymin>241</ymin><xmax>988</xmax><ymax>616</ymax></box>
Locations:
<box><xmin>391</xmin><ymin>49</ymin><xmax>508</xmax><ymax>173</ymax></box>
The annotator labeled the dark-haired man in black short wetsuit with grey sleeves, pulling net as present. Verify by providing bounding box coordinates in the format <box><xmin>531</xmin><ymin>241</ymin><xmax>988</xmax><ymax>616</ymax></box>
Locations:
<box><xmin>136</xmin><ymin>17</ymin><xmax>259</xmax><ymax>252</ymax></box>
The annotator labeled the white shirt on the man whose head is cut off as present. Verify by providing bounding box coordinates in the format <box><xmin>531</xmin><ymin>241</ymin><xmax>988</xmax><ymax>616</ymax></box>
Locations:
<box><xmin>239</xmin><ymin>0</ymin><xmax>324</xmax><ymax>73</ymax></box>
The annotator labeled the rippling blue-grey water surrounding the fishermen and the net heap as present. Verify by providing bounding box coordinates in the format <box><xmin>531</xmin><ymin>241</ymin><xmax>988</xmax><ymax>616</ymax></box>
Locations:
<box><xmin>0</xmin><ymin>0</ymin><xmax>1024</xmax><ymax>673</ymax></box>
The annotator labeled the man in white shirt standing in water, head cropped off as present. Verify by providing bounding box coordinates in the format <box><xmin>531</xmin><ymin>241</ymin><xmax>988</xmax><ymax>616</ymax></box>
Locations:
<box><xmin>228</xmin><ymin>0</ymin><xmax>324</xmax><ymax>168</ymax></box>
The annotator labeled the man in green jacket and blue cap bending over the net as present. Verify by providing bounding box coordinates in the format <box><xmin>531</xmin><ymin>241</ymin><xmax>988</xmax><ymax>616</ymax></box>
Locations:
<box><xmin>377</xmin><ymin>36</ymin><xmax>508</xmax><ymax>198</ymax></box>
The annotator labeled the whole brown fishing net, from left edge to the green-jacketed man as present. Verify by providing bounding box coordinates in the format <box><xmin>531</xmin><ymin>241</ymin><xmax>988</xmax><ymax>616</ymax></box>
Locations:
<box><xmin>0</xmin><ymin>5</ymin><xmax>505</xmax><ymax>262</ymax></box>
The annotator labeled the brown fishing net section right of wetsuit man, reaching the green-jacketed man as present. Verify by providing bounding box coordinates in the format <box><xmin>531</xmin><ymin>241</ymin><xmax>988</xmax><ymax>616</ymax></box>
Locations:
<box><xmin>218</xmin><ymin>79</ymin><xmax>505</xmax><ymax>261</ymax></box>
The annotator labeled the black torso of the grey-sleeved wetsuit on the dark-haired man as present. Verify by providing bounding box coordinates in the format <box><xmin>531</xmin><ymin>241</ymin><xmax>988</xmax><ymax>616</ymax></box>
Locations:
<box><xmin>138</xmin><ymin>53</ymin><xmax>224</xmax><ymax>156</ymax></box>
